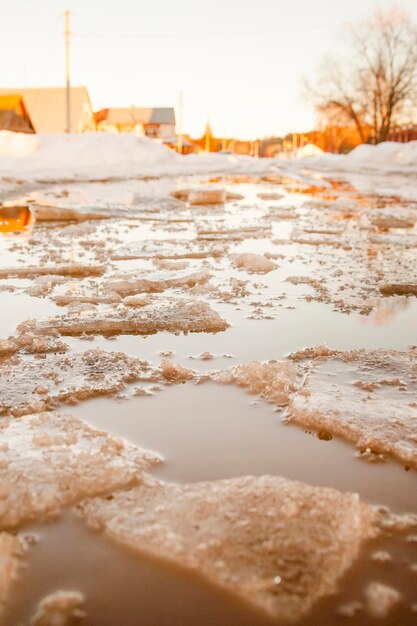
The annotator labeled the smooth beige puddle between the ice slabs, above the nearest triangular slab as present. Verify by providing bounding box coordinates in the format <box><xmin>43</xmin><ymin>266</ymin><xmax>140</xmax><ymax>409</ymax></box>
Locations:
<box><xmin>71</xmin><ymin>383</ymin><xmax>417</xmax><ymax>512</ymax></box>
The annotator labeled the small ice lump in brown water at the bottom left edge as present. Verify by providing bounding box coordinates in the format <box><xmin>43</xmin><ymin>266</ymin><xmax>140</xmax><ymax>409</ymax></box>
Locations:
<box><xmin>30</xmin><ymin>591</ymin><xmax>86</xmax><ymax>626</ymax></box>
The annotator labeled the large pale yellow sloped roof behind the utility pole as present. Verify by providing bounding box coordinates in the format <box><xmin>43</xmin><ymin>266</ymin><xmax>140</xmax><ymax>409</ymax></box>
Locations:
<box><xmin>0</xmin><ymin>87</ymin><xmax>95</xmax><ymax>133</ymax></box>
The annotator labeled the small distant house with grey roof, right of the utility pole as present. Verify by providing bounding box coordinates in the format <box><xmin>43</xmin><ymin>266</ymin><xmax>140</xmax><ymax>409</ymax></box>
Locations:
<box><xmin>94</xmin><ymin>107</ymin><xmax>175</xmax><ymax>139</ymax></box>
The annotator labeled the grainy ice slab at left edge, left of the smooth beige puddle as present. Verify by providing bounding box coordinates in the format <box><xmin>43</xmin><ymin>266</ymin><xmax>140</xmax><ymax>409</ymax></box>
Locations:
<box><xmin>0</xmin><ymin>412</ymin><xmax>159</xmax><ymax>528</ymax></box>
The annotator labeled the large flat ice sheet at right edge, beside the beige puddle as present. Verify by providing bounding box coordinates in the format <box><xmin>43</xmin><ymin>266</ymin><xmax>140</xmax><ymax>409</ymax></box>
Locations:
<box><xmin>289</xmin><ymin>348</ymin><xmax>417</xmax><ymax>468</ymax></box>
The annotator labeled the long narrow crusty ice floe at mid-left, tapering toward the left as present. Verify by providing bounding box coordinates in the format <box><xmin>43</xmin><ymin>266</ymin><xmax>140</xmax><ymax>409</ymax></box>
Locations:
<box><xmin>18</xmin><ymin>297</ymin><xmax>229</xmax><ymax>336</ymax></box>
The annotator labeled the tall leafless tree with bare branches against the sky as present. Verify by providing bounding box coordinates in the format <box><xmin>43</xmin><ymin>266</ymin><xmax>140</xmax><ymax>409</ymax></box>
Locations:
<box><xmin>307</xmin><ymin>8</ymin><xmax>417</xmax><ymax>143</ymax></box>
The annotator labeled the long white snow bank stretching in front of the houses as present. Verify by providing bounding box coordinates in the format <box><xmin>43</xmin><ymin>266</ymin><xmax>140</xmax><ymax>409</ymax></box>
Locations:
<box><xmin>0</xmin><ymin>131</ymin><xmax>417</xmax><ymax>184</ymax></box>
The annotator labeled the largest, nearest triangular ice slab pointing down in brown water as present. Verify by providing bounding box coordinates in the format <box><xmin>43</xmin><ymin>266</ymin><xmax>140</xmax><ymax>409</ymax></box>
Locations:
<box><xmin>78</xmin><ymin>476</ymin><xmax>373</xmax><ymax>622</ymax></box>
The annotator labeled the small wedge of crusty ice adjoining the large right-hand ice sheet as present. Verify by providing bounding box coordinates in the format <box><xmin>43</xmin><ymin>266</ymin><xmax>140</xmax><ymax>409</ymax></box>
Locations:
<box><xmin>212</xmin><ymin>361</ymin><xmax>299</xmax><ymax>406</ymax></box>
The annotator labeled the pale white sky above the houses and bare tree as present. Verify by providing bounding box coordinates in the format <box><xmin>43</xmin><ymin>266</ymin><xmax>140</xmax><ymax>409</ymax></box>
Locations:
<box><xmin>0</xmin><ymin>0</ymin><xmax>417</xmax><ymax>139</ymax></box>
